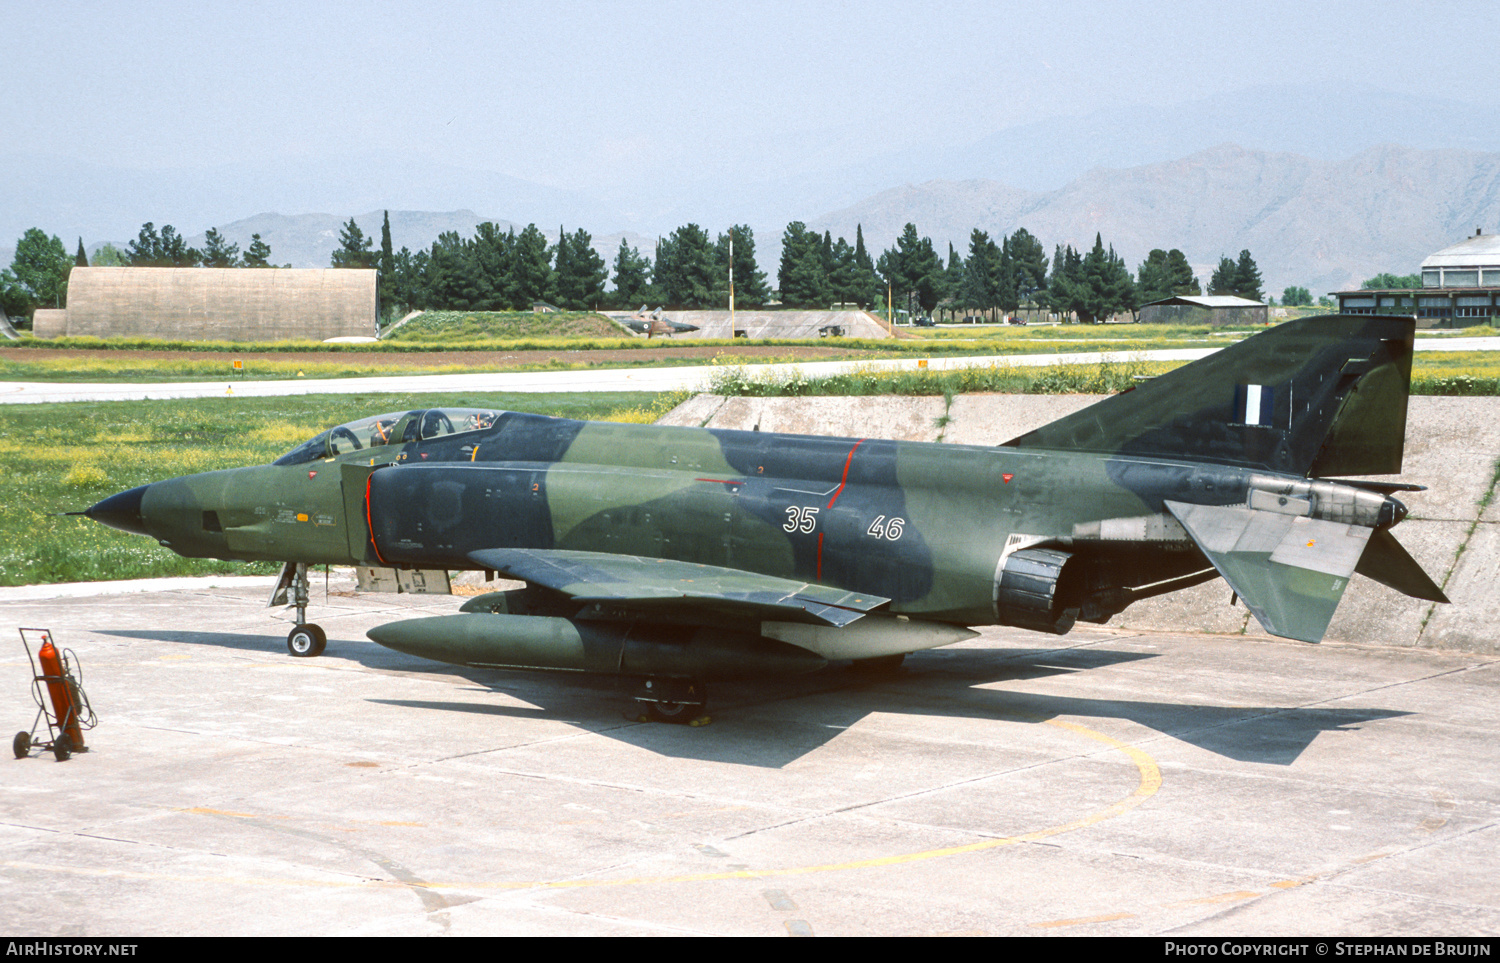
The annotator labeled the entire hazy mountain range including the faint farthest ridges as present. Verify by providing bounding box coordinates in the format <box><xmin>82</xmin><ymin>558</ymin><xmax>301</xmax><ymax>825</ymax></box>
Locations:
<box><xmin>0</xmin><ymin>79</ymin><xmax>1500</xmax><ymax>294</ymax></box>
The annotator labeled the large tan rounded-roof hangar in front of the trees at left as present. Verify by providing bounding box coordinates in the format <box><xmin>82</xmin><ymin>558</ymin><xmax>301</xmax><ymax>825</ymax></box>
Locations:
<box><xmin>33</xmin><ymin>267</ymin><xmax>380</xmax><ymax>341</ymax></box>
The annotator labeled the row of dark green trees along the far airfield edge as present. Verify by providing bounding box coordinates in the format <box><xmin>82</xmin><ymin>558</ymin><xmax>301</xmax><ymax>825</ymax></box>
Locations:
<box><xmin>0</xmin><ymin>213</ymin><xmax>1338</xmax><ymax>323</ymax></box>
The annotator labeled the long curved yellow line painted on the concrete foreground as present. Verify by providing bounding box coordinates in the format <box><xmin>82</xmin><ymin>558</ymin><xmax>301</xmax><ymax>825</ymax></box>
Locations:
<box><xmin>0</xmin><ymin>719</ymin><xmax>1158</xmax><ymax>896</ymax></box>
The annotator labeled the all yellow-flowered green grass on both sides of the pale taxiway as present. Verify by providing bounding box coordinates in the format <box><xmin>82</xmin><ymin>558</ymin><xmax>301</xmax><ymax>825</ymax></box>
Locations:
<box><xmin>0</xmin><ymin>312</ymin><xmax>1500</xmax><ymax>585</ymax></box>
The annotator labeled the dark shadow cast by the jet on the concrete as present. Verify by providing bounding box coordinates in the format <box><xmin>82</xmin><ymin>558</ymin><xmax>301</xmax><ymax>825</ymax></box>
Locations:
<box><xmin>99</xmin><ymin>630</ymin><xmax>1410</xmax><ymax>768</ymax></box>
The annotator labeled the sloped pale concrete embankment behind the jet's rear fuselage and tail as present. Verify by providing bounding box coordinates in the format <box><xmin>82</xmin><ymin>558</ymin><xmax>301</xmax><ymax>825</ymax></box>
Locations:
<box><xmin>660</xmin><ymin>395</ymin><xmax>1500</xmax><ymax>653</ymax></box>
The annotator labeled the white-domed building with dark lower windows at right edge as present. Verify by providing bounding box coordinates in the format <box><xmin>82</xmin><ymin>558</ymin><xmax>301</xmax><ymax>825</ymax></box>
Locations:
<box><xmin>1334</xmin><ymin>231</ymin><xmax>1500</xmax><ymax>327</ymax></box>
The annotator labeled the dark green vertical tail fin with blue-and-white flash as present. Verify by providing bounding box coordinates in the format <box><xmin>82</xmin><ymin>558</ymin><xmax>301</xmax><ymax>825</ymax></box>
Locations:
<box><xmin>1005</xmin><ymin>315</ymin><xmax>1416</xmax><ymax>477</ymax></box>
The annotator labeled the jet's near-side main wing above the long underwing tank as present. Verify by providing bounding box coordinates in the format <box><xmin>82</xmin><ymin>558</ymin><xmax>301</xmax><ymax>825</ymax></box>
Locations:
<box><xmin>470</xmin><ymin>549</ymin><xmax>890</xmax><ymax>627</ymax></box>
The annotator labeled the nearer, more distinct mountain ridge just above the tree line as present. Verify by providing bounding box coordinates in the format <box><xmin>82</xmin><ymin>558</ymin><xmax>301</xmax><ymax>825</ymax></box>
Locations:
<box><xmin>70</xmin><ymin>144</ymin><xmax>1500</xmax><ymax>296</ymax></box>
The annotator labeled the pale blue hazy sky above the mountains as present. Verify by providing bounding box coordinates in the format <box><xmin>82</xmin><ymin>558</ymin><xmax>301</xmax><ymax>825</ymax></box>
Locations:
<box><xmin>0</xmin><ymin>0</ymin><xmax>1500</xmax><ymax>246</ymax></box>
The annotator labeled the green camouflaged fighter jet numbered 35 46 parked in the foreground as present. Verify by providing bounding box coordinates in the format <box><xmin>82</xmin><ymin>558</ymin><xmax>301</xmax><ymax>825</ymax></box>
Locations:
<box><xmin>86</xmin><ymin>315</ymin><xmax>1446</xmax><ymax>722</ymax></box>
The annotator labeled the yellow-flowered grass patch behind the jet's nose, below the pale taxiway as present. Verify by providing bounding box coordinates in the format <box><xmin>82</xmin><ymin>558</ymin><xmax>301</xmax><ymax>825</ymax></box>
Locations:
<box><xmin>0</xmin><ymin>393</ymin><xmax>669</xmax><ymax>585</ymax></box>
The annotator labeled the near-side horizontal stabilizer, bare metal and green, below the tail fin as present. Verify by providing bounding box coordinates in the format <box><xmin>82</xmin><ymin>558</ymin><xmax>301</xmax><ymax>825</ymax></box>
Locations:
<box><xmin>1166</xmin><ymin>501</ymin><xmax>1374</xmax><ymax>642</ymax></box>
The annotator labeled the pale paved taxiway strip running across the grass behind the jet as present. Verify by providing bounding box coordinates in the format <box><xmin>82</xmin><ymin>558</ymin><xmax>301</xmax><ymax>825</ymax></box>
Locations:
<box><xmin>0</xmin><ymin>338</ymin><xmax>1500</xmax><ymax>405</ymax></box>
